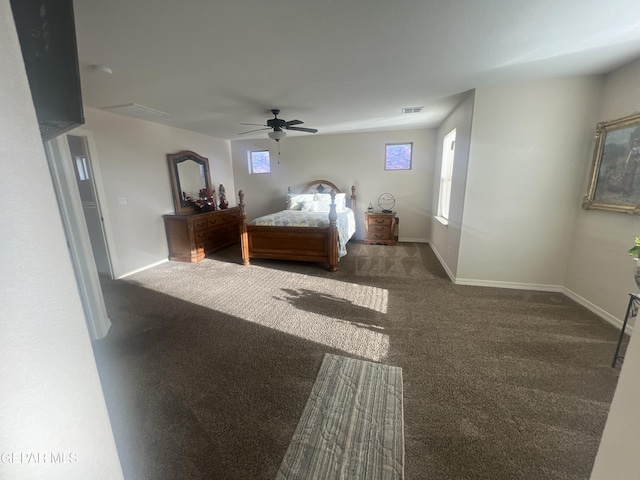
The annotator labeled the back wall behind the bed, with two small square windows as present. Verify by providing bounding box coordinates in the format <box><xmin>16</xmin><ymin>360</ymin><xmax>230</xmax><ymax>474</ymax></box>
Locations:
<box><xmin>229</xmin><ymin>129</ymin><xmax>436</xmax><ymax>242</ymax></box>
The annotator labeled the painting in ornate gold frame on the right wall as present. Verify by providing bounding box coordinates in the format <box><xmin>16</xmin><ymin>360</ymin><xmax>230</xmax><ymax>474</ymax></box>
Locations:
<box><xmin>582</xmin><ymin>113</ymin><xmax>640</xmax><ymax>215</ymax></box>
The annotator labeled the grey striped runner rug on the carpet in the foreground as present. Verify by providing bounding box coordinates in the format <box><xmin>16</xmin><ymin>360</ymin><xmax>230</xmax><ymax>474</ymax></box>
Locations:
<box><xmin>276</xmin><ymin>354</ymin><xmax>404</xmax><ymax>480</ymax></box>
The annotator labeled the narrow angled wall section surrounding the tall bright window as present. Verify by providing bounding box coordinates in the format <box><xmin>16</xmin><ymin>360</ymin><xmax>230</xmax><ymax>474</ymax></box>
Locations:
<box><xmin>431</xmin><ymin>92</ymin><xmax>475</xmax><ymax>278</ymax></box>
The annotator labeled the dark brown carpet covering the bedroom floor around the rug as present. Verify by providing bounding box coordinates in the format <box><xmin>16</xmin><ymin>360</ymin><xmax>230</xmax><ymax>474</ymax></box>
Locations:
<box><xmin>94</xmin><ymin>243</ymin><xmax>619</xmax><ymax>480</ymax></box>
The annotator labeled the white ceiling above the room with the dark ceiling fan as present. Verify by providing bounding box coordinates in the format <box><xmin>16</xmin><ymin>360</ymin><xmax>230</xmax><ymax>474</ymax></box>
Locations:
<box><xmin>74</xmin><ymin>0</ymin><xmax>640</xmax><ymax>139</ymax></box>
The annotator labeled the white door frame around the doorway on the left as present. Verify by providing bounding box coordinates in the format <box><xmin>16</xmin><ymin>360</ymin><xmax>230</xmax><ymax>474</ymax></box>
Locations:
<box><xmin>44</xmin><ymin>129</ymin><xmax>115</xmax><ymax>340</ymax></box>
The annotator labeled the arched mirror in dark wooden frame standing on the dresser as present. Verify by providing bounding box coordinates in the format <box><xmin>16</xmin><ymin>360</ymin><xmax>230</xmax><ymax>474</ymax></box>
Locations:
<box><xmin>167</xmin><ymin>150</ymin><xmax>211</xmax><ymax>215</ymax></box>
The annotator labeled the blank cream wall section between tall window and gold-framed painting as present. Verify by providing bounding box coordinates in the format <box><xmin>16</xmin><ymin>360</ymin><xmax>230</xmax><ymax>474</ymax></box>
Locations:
<box><xmin>456</xmin><ymin>77</ymin><xmax>602</xmax><ymax>290</ymax></box>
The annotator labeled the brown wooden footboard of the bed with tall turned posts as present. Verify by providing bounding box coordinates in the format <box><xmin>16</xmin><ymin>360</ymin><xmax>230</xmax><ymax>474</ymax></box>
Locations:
<box><xmin>238</xmin><ymin>187</ymin><xmax>355</xmax><ymax>272</ymax></box>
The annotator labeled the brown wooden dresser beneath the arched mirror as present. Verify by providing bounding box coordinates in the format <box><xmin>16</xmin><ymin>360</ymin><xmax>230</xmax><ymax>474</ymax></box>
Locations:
<box><xmin>162</xmin><ymin>207</ymin><xmax>240</xmax><ymax>262</ymax></box>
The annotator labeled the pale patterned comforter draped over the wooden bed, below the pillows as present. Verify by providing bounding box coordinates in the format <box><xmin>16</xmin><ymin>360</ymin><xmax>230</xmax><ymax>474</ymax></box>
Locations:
<box><xmin>249</xmin><ymin>208</ymin><xmax>356</xmax><ymax>257</ymax></box>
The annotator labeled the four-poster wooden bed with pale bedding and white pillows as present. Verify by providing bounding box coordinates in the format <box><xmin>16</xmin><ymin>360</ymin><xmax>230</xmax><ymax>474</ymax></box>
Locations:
<box><xmin>238</xmin><ymin>180</ymin><xmax>356</xmax><ymax>272</ymax></box>
